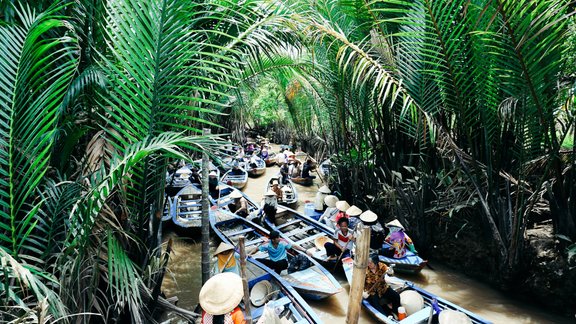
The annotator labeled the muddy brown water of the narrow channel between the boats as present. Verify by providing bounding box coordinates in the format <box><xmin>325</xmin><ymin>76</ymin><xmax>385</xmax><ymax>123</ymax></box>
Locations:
<box><xmin>162</xmin><ymin>167</ymin><xmax>574</xmax><ymax>324</ymax></box>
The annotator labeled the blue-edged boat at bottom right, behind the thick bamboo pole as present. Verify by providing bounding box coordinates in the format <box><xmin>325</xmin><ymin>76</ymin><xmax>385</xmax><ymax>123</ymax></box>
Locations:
<box><xmin>342</xmin><ymin>258</ymin><xmax>490</xmax><ymax>324</ymax></box>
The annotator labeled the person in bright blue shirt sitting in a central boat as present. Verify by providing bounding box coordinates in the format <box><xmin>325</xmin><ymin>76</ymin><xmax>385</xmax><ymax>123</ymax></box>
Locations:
<box><xmin>256</xmin><ymin>231</ymin><xmax>308</xmax><ymax>274</ymax></box>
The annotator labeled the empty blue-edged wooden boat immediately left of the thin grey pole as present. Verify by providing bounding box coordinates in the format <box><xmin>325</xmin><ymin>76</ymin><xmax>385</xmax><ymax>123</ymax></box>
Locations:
<box><xmin>172</xmin><ymin>185</ymin><xmax>202</xmax><ymax>229</ymax></box>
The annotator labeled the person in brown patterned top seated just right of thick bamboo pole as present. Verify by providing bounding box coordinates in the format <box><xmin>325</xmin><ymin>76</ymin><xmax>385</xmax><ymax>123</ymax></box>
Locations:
<box><xmin>362</xmin><ymin>255</ymin><xmax>401</xmax><ymax>316</ymax></box>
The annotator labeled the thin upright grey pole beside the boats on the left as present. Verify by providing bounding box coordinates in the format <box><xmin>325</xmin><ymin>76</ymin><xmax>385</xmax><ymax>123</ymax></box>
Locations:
<box><xmin>202</xmin><ymin>128</ymin><xmax>210</xmax><ymax>285</ymax></box>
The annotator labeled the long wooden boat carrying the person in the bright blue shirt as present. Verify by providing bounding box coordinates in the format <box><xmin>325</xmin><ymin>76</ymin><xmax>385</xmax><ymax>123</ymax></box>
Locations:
<box><xmin>210</xmin><ymin>209</ymin><xmax>342</xmax><ymax>300</ymax></box>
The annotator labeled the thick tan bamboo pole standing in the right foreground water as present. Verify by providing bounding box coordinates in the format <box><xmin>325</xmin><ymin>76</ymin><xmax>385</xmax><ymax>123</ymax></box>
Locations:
<box><xmin>346</xmin><ymin>223</ymin><xmax>370</xmax><ymax>324</ymax></box>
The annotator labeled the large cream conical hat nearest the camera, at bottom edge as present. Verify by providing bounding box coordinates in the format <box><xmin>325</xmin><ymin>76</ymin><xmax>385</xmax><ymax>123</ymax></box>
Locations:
<box><xmin>199</xmin><ymin>272</ymin><xmax>244</xmax><ymax>315</ymax></box>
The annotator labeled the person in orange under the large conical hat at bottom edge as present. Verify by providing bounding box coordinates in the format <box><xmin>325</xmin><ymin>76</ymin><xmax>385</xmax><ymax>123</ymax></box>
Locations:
<box><xmin>198</xmin><ymin>272</ymin><xmax>246</xmax><ymax>324</ymax></box>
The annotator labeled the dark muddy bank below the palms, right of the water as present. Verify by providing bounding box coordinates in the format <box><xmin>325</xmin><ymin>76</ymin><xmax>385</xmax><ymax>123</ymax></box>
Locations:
<box><xmin>413</xmin><ymin>217</ymin><xmax>576</xmax><ymax>319</ymax></box>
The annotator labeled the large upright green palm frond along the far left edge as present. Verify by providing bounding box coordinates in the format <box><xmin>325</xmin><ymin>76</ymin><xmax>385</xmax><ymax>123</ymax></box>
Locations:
<box><xmin>0</xmin><ymin>1</ymin><xmax>78</xmax><ymax>258</ymax></box>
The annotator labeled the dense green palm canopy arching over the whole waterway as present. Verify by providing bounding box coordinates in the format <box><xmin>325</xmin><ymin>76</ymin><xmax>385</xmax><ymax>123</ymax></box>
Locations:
<box><xmin>0</xmin><ymin>0</ymin><xmax>576</xmax><ymax>322</ymax></box>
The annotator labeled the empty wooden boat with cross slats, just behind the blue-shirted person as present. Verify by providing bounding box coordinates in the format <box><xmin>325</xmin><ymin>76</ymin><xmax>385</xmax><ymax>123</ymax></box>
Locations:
<box><xmin>263</xmin><ymin>206</ymin><xmax>335</xmax><ymax>269</ymax></box>
